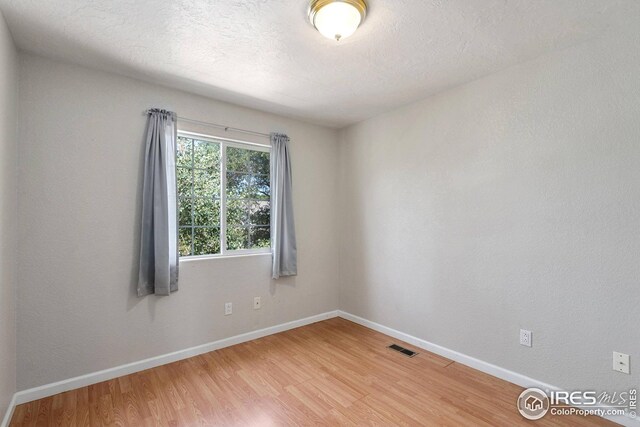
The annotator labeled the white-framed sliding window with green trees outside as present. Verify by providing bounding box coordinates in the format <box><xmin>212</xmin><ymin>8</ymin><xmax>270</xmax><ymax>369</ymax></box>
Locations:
<box><xmin>176</xmin><ymin>132</ymin><xmax>271</xmax><ymax>257</ymax></box>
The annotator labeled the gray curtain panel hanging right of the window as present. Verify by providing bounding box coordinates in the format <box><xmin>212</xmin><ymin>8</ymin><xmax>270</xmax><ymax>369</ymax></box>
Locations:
<box><xmin>271</xmin><ymin>133</ymin><xmax>298</xmax><ymax>279</ymax></box>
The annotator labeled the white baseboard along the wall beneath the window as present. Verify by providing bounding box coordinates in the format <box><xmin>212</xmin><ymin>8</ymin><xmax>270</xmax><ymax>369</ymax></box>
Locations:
<box><xmin>10</xmin><ymin>310</ymin><xmax>338</xmax><ymax>408</ymax></box>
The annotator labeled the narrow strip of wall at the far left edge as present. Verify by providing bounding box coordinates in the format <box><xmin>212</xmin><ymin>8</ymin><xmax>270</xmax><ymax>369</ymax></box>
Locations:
<box><xmin>0</xmin><ymin>8</ymin><xmax>18</xmax><ymax>420</ymax></box>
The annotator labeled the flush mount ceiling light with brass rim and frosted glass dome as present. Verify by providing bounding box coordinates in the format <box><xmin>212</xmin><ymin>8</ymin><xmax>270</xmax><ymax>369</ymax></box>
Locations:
<box><xmin>309</xmin><ymin>0</ymin><xmax>367</xmax><ymax>41</ymax></box>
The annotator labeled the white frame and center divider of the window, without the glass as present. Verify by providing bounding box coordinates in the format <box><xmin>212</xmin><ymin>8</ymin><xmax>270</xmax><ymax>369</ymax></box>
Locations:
<box><xmin>176</xmin><ymin>129</ymin><xmax>271</xmax><ymax>261</ymax></box>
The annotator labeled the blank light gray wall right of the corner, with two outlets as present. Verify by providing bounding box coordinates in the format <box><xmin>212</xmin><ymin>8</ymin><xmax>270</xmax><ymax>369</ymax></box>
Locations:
<box><xmin>340</xmin><ymin>30</ymin><xmax>640</xmax><ymax>391</ymax></box>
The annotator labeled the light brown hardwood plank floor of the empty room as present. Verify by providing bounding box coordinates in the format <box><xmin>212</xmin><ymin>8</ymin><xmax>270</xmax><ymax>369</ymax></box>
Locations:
<box><xmin>10</xmin><ymin>318</ymin><xmax>613</xmax><ymax>427</ymax></box>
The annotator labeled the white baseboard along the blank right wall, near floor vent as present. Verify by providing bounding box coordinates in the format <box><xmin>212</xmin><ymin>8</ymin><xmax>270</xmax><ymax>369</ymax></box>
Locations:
<box><xmin>338</xmin><ymin>310</ymin><xmax>640</xmax><ymax>427</ymax></box>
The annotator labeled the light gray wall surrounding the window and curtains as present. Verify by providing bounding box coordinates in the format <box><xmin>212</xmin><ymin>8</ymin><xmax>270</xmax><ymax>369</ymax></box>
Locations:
<box><xmin>18</xmin><ymin>55</ymin><xmax>338</xmax><ymax>390</ymax></box>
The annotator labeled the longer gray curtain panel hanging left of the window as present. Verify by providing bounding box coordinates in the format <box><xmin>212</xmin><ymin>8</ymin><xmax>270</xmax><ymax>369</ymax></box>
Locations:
<box><xmin>138</xmin><ymin>109</ymin><xmax>178</xmax><ymax>296</ymax></box>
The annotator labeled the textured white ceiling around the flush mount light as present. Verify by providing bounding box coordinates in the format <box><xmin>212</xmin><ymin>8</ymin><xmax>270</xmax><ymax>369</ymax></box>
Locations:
<box><xmin>0</xmin><ymin>0</ymin><xmax>640</xmax><ymax>127</ymax></box>
